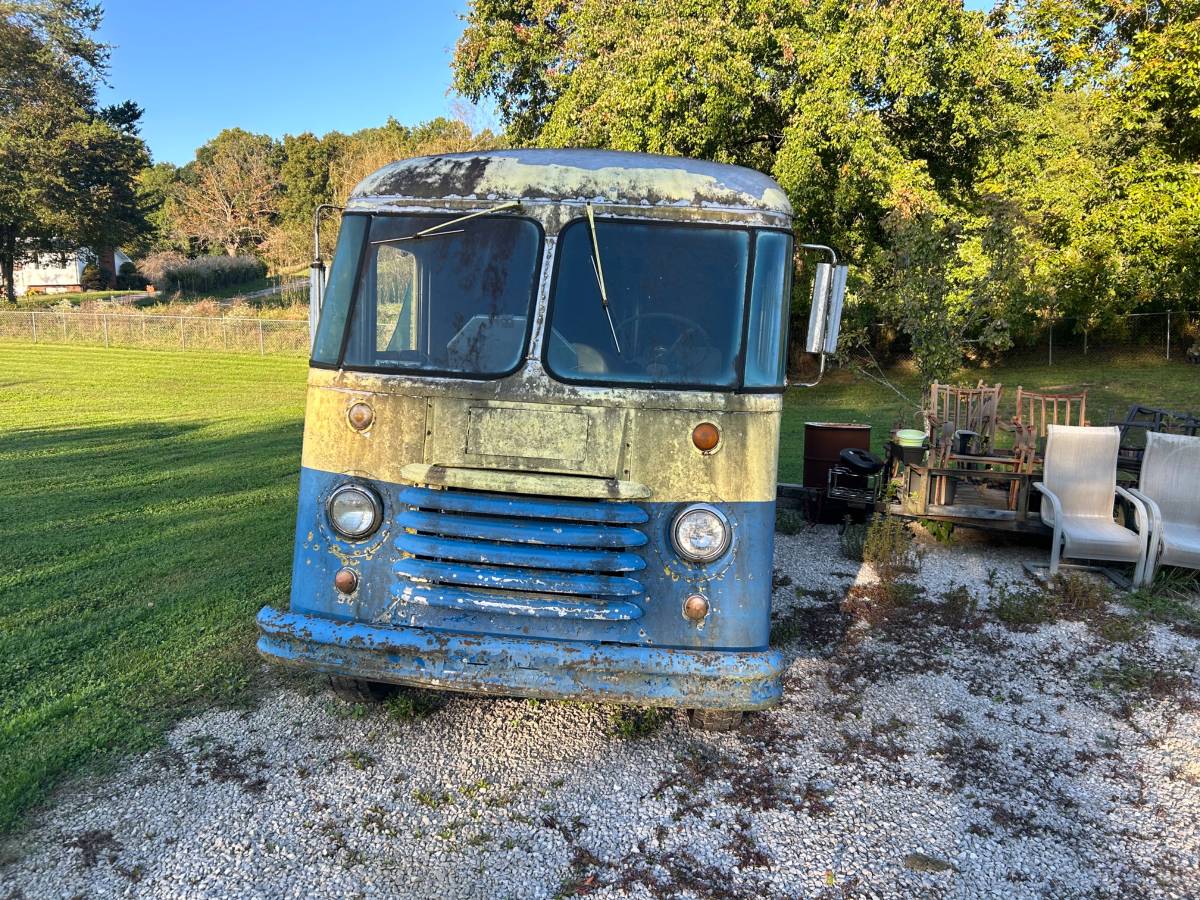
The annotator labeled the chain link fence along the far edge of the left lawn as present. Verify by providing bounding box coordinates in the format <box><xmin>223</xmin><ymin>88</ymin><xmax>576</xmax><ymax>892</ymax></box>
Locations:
<box><xmin>0</xmin><ymin>310</ymin><xmax>308</xmax><ymax>355</ymax></box>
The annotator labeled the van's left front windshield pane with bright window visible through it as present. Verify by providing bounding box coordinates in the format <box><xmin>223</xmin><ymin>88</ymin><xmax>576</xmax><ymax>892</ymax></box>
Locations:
<box><xmin>318</xmin><ymin>215</ymin><xmax>541</xmax><ymax>378</ymax></box>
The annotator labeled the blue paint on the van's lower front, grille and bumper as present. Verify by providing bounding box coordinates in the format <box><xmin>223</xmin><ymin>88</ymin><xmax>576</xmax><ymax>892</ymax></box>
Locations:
<box><xmin>260</xmin><ymin>468</ymin><xmax>779</xmax><ymax>708</ymax></box>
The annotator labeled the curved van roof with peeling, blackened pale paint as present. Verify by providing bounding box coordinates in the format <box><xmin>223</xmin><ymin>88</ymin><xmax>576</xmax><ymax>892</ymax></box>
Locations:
<box><xmin>349</xmin><ymin>150</ymin><xmax>792</xmax><ymax>216</ymax></box>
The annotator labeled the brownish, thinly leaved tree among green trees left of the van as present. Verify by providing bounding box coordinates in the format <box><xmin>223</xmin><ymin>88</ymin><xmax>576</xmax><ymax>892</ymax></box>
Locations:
<box><xmin>174</xmin><ymin>128</ymin><xmax>280</xmax><ymax>256</ymax></box>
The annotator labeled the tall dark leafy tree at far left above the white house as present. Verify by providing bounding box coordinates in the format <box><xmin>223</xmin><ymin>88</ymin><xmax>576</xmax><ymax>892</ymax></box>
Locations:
<box><xmin>0</xmin><ymin>0</ymin><xmax>149</xmax><ymax>302</ymax></box>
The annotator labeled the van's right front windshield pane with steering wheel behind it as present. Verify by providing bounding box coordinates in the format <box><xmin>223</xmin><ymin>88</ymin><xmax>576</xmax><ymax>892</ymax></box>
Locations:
<box><xmin>545</xmin><ymin>218</ymin><xmax>750</xmax><ymax>388</ymax></box>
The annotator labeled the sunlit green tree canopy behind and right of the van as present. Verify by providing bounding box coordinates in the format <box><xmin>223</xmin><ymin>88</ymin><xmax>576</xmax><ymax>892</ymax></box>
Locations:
<box><xmin>454</xmin><ymin>0</ymin><xmax>1200</xmax><ymax>378</ymax></box>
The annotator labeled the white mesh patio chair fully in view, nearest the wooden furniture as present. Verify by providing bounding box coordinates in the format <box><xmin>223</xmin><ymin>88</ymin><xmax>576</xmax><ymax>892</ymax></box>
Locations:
<box><xmin>1033</xmin><ymin>425</ymin><xmax>1150</xmax><ymax>588</ymax></box>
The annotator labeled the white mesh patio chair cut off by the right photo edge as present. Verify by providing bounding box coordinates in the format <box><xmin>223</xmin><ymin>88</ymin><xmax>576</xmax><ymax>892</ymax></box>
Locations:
<box><xmin>1130</xmin><ymin>432</ymin><xmax>1200</xmax><ymax>584</ymax></box>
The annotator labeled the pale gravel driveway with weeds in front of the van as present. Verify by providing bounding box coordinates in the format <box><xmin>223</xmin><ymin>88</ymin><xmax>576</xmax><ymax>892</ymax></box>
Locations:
<box><xmin>0</xmin><ymin>527</ymin><xmax>1200</xmax><ymax>898</ymax></box>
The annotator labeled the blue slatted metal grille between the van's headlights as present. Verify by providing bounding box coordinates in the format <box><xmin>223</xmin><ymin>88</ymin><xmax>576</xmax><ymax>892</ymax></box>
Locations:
<box><xmin>395</xmin><ymin>487</ymin><xmax>648</xmax><ymax>620</ymax></box>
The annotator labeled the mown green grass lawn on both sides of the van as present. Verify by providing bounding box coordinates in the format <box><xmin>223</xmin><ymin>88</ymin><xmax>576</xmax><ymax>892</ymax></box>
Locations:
<box><xmin>0</xmin><ymin>343</ymin><xmax>1200</xmax><ymax>830</ymax></box>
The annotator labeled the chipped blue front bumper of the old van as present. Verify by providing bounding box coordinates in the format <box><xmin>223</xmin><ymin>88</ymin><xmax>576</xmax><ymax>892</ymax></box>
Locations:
<box><xmin>258</xmin><ymin>607</ymin><xmax>784</xmax><ymax>709</ymax></box>
